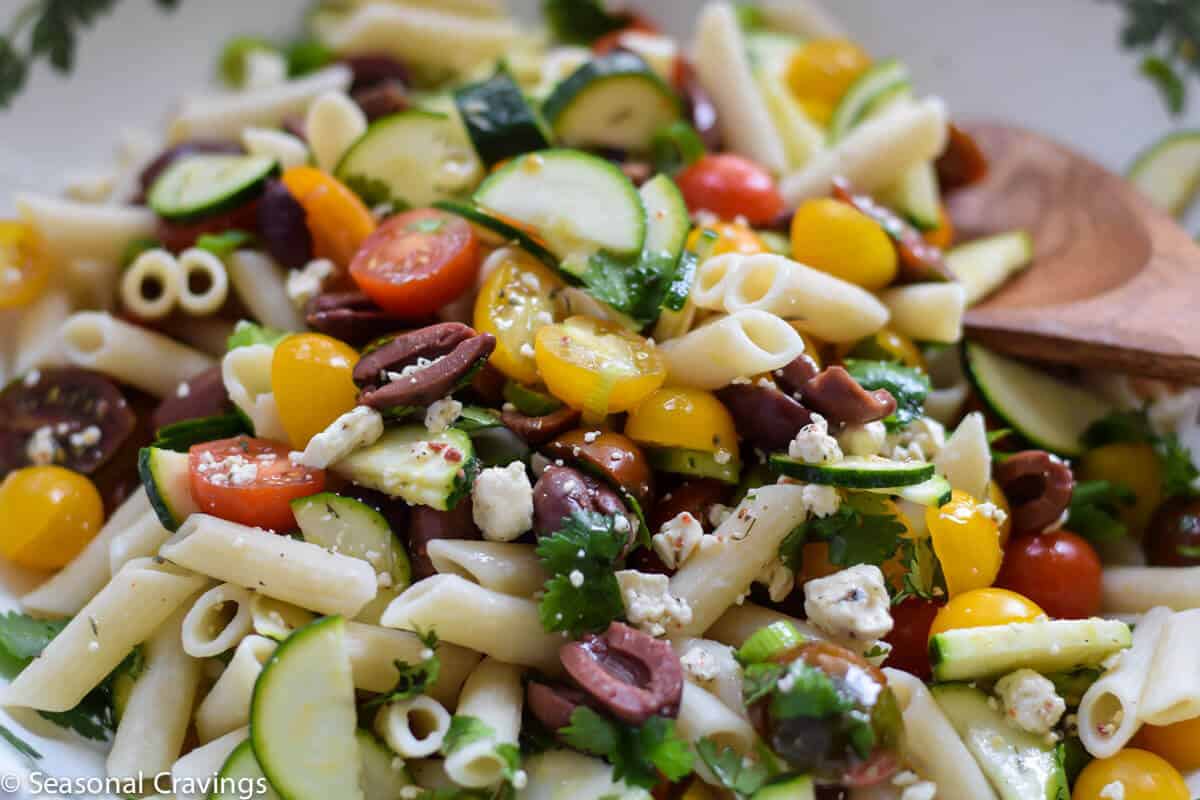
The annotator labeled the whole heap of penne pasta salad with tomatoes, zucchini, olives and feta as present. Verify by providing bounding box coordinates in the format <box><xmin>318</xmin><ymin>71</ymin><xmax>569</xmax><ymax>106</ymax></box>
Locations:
<box><xmin>0</xmin><ymin>0</ymin><xmax>1200</xmax><ymax>800</ymax></box>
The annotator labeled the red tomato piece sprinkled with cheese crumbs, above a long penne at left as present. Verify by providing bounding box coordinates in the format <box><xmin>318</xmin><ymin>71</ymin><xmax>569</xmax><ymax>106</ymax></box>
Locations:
<box><xmin>187</xmin><ymin>437</ymin><xmax>325</xmax><ymax>533</ymax></box>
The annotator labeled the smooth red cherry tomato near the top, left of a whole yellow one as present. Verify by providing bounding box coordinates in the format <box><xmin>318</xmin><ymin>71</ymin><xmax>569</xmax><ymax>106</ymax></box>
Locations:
<box><xmin>676</xmin><ymin>152</ymin><xmax>784</xmax><ymax>225</ymax></box>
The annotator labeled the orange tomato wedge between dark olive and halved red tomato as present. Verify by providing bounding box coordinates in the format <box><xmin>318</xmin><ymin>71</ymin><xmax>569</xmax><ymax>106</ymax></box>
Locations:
<box><xmin>280</xmin><ymin>167</ymin><xmax>376</xmax><ymax>267</ymax></box>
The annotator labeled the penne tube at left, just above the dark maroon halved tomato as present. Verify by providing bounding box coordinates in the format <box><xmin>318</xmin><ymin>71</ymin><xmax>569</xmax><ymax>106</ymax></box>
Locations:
<box><xmin>61</xmin><ymin>311</ymin><xmax>214</xmax><ymax>397</ymax></box>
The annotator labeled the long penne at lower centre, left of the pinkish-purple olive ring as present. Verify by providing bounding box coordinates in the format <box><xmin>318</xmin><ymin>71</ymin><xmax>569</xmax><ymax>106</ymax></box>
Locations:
<box><xmin>382</xmin><ymin>575</ymin><xmax>563</xmax><ymax>673</ymax></box>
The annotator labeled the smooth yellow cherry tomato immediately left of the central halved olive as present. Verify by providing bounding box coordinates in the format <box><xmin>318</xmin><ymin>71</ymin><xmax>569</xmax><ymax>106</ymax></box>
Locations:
<box><xmin>271</xmin><ymin>333</ymin><xmax>359</xmax><ymax>450</ymax></box>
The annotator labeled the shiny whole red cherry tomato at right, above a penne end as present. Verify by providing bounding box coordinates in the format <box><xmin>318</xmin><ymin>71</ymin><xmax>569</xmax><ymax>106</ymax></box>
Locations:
<box><xmin>996</xmin><ymin>530</ymin><xmax>1100</xmax><ymax>619</ymax></box>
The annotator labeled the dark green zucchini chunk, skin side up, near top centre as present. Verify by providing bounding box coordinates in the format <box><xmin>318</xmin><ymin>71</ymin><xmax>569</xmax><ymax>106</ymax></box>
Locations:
<box><xmin>454</xmin><ymin>64</ymin><xmax>550</xmax><ymax>167</ymax></box>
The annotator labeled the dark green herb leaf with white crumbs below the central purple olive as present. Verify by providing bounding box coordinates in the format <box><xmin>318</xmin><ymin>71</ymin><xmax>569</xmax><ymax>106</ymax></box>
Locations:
<box><xmin>536</xmin><ymin>511</ymin><xmax>625</xmax><ymax>636</ymax></box>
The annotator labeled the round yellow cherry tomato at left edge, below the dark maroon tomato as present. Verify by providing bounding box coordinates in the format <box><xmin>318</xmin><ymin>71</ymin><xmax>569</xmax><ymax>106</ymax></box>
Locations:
<box><xmin>0</xmin><ymin>467</ymin><xmax>104</xmax><ymax>570</ymax></box>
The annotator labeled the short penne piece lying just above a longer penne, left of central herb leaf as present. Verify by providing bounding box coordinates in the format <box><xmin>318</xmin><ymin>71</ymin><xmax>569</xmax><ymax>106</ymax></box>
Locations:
<box><xmin>427</xmin><ymin>539</ymin><xmax>548</xmax><ymax>597</ymax></box>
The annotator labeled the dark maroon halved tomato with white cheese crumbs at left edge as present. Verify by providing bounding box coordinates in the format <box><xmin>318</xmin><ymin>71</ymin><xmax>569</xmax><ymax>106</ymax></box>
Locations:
<box><xmin>0</xmin><ymin>367</ymin><xmax>134</xmax><ymax>477</ymax></box>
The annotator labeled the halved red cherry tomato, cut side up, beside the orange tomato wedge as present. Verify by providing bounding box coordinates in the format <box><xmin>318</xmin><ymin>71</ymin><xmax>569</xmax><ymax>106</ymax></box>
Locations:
<box><xmin>350</xmin><ymin>209</ymin><xmax>479</xmax><ymax>317</ymax></box>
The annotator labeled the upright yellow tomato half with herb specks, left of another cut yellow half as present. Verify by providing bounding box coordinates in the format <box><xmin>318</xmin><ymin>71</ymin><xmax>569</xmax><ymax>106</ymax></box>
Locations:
<box><xmin>474</xmin><ymin>248</ymin><xmax>565</xmax><ymax>385</ymax></box>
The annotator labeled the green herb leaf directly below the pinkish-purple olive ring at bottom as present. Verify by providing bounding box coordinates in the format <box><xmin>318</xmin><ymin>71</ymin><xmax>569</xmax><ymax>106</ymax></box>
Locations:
<box><xmin>558</xmin><ymin>706</ymin><xmax>692</xmax><ymax>789</ymax></box>
